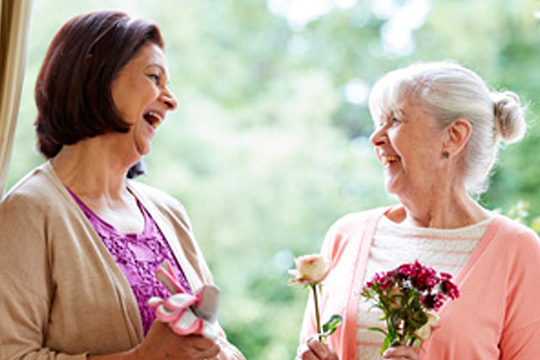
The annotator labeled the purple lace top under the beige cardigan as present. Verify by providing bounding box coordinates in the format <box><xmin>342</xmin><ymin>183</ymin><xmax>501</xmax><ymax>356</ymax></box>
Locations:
<box><xmin>68</xmin><ymin>189</ymin><xmax>191</xmax><ymax>335</ymax></box>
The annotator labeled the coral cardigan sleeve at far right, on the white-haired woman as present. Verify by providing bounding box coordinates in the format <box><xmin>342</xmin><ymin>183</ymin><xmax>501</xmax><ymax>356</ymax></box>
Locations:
<box><xmin>500</xmin><ymin>229</ymin><xmax>540</xmax><ymax>360</ymax></box>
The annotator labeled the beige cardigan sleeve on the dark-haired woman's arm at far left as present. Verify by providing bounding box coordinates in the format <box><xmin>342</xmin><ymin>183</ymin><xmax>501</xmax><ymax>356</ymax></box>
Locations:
<box><xmin>0</xmin><ymin>196</ymin><xmax>86</xmax><ymax>360</ymax></box>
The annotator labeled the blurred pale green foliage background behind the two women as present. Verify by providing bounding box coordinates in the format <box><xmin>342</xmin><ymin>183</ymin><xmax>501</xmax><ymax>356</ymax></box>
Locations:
<box><xmin>9</xmin><ymin>0</ymin><xmax>540</xmax><ymax>360</ymax></box>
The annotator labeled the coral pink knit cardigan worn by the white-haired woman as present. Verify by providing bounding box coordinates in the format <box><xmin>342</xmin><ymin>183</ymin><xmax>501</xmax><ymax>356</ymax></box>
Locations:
<box><xmin>301</xmin><ymin>208</ymin><xmax>540</xmax><ymax>360</ymax></box>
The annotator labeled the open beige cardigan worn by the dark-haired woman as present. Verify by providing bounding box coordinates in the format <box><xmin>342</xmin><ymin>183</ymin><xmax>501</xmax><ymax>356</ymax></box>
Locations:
<box><xmin>0</xmin><ymin>163</ymin><xmax>243</xmax><ymax>360</ymax></box>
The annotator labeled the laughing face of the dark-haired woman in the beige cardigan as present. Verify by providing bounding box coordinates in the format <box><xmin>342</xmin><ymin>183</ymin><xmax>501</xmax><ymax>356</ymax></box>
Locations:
<box><xmin>112</xmin><ymin>42</ymin><xmax>177</xmax><ymax>160</ymax></box>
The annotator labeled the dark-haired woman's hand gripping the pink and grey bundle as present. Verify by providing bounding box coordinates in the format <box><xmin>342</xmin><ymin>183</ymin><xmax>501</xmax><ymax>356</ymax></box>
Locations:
<box><xmin>135</xmin><ymin>321</ymin><xmax>220</xmax><ymax>360</ymax></box>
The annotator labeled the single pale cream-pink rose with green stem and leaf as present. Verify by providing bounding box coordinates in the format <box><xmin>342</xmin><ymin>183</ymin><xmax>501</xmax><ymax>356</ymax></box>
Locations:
<box><xmin>289</xmin><ymin>254</ymin><xmax>343</xmax><ymax>344</ymax></box>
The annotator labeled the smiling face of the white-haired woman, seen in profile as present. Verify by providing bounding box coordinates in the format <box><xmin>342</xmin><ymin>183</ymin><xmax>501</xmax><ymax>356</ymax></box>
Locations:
<box><xmin>370</xmin><ymin>97</ymin><xmax>444</xmax><ymax>197</ymax></box>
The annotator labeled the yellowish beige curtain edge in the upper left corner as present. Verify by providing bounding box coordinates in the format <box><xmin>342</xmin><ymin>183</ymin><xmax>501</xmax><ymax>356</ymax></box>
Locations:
<box><xmin>0</xmin><ymin>0</ymin><xmax>32</xmax><ymax>197</ymax></box>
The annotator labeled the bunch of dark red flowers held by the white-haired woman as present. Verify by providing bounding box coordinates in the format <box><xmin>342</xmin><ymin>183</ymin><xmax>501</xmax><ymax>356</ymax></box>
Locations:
<box><xmin>360</xmin><ymin>261</ymin><xmax>459</xmax><ymax>353</ymax></box>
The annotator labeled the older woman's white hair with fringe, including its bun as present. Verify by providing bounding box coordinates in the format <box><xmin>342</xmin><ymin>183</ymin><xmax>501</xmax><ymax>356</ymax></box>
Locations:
<box><xmin>369</xmin><ymin>62</ymin><xmax>526</xmax><ymax>194</ymax></box>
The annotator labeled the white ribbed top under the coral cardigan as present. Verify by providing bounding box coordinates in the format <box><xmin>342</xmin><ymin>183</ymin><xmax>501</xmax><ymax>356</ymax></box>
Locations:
<box><xmin>357</xmin><ymin>216</ymin><xmax>491</xmax><ymax>360</ymax></box>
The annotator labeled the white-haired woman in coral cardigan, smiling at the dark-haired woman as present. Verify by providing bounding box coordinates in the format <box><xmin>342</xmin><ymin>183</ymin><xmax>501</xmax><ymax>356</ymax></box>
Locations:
<box><xmin>297</xmin><ymin>62</ymin><xmax>540</xmax><ymax>360</ymax></box>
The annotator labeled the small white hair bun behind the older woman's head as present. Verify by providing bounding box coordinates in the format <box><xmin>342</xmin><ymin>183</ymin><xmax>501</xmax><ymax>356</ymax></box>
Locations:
<box><xmin>492</xmin><ymin>91</ymin><xmax>526</xmax><ymax>143</ymax></box>
